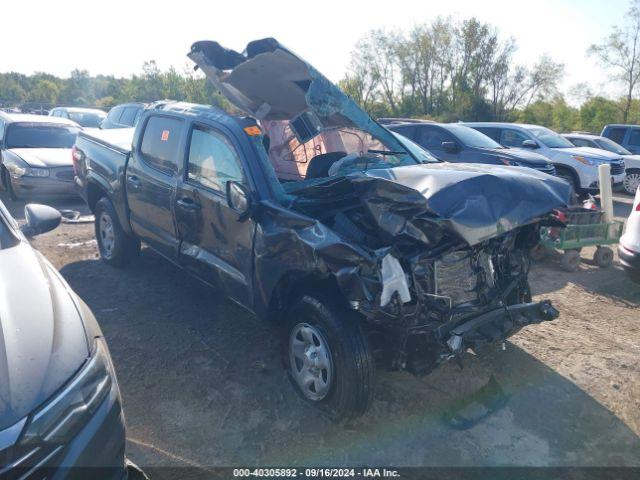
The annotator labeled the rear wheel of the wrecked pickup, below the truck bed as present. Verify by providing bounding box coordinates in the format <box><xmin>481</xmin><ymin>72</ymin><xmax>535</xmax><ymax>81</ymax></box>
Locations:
<box><xmin>93</xmin><ymin>197</ymin><xmax>140</xmax><ymax>267</ymax></box>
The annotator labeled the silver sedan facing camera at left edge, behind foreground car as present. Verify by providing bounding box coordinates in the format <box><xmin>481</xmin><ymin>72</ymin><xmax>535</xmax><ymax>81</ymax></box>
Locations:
<box><xmin>0</xmin><ymin>112</ymin><xmax>80</xmax><ymax>199</ymax></box>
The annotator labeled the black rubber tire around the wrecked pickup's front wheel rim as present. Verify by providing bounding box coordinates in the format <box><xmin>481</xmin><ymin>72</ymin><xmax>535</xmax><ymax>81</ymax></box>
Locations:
<box><xmin>283</xmin><ymin>294</ymin><xmax>375</xmax><ymax>423</ymax></box>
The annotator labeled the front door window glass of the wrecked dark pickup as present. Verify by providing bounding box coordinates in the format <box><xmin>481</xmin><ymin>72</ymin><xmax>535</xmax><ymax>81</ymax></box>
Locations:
<box><xmin>187</xmin><ymin>127</ymin><xmax>244</xmax><ymax>192</ymax></box>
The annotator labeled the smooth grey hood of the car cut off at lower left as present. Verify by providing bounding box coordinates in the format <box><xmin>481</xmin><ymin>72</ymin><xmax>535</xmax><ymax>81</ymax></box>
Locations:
<box><xmin>0</xmin><ymin>242</ymin><xmax>89</xmax><ymax>430</ymax></box>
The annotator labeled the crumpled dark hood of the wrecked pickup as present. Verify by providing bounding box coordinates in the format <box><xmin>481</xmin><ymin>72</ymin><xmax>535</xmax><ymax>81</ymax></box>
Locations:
<box><xmin>292</xmin><ymin>163</ymin><xmax>570</xmax><ymax>246</ymax></box>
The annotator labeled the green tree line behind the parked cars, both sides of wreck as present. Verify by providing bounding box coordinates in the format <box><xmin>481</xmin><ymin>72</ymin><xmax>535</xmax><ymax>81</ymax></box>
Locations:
<box><xmin>0</xmin><ymin>0</ymin><xmax>640</xmax><ymax>133</ymax></box>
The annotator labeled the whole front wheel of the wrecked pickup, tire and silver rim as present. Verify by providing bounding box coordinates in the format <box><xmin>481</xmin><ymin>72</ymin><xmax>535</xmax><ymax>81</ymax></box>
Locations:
<box><xmin>283</xmin><ymin>294</ymin><xmax>375</xmax><ymax>422</ymax></box>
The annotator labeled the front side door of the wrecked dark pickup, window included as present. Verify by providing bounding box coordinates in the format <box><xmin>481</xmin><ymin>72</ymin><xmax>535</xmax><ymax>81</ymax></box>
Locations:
<box><xmin>175</xmin><ymin>123</ymin><xmax>255</xmax><ymax>307</ymax></box>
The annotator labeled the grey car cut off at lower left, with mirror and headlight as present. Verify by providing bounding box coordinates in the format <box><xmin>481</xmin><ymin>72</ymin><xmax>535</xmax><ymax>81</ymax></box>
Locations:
<box><xmin>0</xmin><ymin>202</ymin><xmax>141</xmax><ymax>480</ymax></box>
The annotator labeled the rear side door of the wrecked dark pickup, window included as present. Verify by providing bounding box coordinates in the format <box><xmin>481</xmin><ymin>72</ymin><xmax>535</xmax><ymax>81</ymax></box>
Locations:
<box><xmin>126</xmin><ymin>113</ymin><xmax>185</xmax><ymax>260</ymax></box>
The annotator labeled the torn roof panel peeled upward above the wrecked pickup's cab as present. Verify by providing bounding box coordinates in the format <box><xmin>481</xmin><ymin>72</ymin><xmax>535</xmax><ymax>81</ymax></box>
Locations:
<box><xmin>188</xmin><ymin>38</ymin><xmax>404</xmax><ymax>151</ymax></box>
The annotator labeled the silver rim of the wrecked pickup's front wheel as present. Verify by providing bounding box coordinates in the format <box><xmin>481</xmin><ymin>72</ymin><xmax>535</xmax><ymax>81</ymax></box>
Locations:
<box><xmin>289</xmin><ymin>323</ymin><xmax>333</xmax><ymax>401</ymax></box>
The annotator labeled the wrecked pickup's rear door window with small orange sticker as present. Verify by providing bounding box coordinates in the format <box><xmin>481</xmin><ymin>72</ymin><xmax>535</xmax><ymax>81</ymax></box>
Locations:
<box><xmin>140</xmin><ymin>116</ymin><xmax>182</xmax><ymax>175</ymax></box>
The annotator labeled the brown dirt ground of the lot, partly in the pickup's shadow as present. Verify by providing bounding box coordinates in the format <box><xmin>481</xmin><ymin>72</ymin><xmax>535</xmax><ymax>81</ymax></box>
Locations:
<box><xmin>5</xmin><ymin>192</ymin><xmax>640</xmax><ymax>469</ymax></box>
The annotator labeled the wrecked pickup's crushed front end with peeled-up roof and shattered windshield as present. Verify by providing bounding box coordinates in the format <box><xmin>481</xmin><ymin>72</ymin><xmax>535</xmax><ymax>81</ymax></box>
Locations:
<box><xmin>189</xmin><ymin>38</ymin><xmax>569</xmax><ymax>374</ymax></box>
